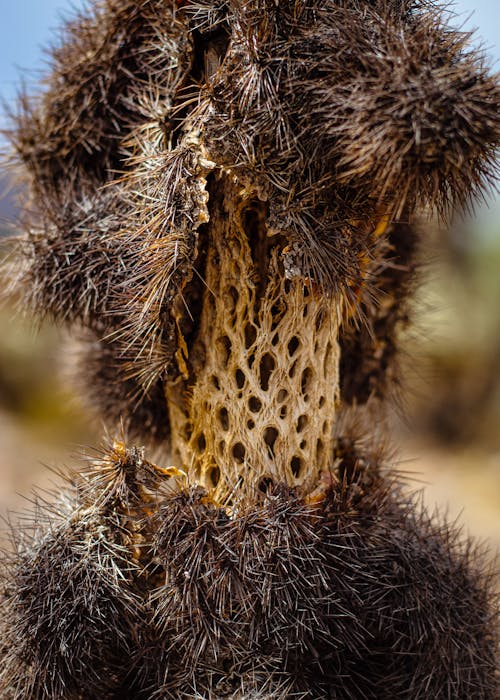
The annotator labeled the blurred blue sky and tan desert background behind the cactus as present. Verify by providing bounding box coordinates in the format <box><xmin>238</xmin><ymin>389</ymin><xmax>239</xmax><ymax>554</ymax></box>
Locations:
<box><xmin>0</xmin><ymin>0</ymin><xmax>500</xmax><ymax>549</ymax></box>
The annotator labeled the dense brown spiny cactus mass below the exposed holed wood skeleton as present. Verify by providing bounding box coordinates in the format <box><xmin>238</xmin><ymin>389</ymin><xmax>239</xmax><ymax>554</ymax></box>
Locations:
<box><xmin>0</xmin><ymin>440</ymin><xmax>495</xmax><ymax>700</ymax></box>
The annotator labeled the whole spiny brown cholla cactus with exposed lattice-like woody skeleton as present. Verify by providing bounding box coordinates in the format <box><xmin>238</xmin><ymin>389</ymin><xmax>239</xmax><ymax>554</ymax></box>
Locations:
<box><xmin>0</xmin><ymin>0</ymin><xmax>500</xmax><ymax>700</ymax></box>
